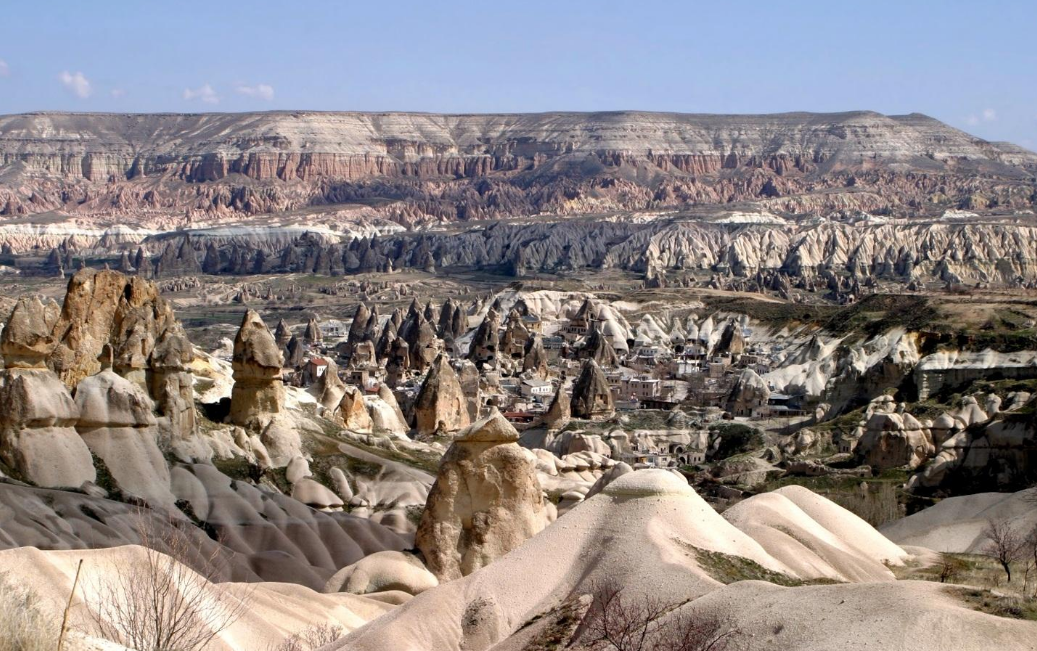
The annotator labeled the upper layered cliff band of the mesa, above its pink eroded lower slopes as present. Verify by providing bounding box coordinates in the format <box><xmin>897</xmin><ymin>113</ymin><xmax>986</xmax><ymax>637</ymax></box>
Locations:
<box><xmin>6</xmin><ymin>111</ymin><xmax>1035</xmax><ymax>180</ymax></box>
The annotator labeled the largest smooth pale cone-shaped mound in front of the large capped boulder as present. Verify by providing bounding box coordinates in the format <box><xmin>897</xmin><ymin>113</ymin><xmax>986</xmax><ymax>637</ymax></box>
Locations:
<box><xmin>330</xmin><ymin>471</ymin><xmax>912</xmax><ymax>651</ymax></box>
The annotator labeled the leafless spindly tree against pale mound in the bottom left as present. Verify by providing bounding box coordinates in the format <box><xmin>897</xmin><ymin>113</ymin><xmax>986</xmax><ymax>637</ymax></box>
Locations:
<box><xmin>87</xmin><ymin>512</ymin><xmax>251</xmax><ymax>651</ymax></box>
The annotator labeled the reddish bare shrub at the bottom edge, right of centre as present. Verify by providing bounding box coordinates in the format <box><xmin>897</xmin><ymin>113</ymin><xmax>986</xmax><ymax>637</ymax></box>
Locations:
<box><xmin>581</xmin><ymin>582</ymin><xmax>736</xmax><ymax>651</ymax></box>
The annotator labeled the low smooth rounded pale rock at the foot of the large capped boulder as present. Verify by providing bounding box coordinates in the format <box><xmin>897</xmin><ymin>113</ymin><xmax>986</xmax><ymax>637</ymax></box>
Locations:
<box><xmin>324</xmin><ymin>550</ymin><xmax>440</xmax><ymax>595</ymax></box>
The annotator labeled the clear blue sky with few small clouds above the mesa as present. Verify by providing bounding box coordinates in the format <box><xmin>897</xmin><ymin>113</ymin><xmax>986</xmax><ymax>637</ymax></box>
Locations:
<box><xmin>0</xmin><ymin>0</ymin><xmax>1037</xmax><ymax>149</ymax></box>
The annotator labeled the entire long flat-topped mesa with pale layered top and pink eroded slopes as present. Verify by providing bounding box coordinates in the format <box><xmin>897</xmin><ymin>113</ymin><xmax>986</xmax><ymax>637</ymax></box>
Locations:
<box><xmin>0</xmin><ymin>112</ymin><xmax>1037</xmax><ymax>227</ymax></box>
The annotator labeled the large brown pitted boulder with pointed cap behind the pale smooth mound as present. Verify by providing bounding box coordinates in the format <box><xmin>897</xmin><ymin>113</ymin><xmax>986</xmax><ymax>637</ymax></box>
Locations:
<box><xmin>415</xmin><ymin>409</ymin><xmax>550</xmax><ymax>581</ymax></box>
